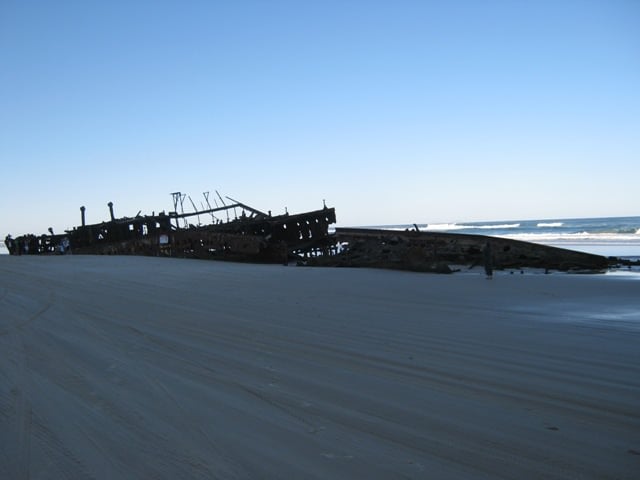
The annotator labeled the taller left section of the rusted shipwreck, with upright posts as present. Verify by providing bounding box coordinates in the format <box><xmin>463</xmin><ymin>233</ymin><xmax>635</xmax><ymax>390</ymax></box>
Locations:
<box><xmin>5</xmin><ymin>197</ymin><xmax>336</xmax><ymax>263</ymax></box>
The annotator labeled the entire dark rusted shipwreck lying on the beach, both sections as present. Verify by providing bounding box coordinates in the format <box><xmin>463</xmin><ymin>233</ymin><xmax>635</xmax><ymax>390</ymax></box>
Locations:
<box><xmin>5</xmin><ymin>192</ymin><xmax>621</xmax><ymax>273</ymax></box>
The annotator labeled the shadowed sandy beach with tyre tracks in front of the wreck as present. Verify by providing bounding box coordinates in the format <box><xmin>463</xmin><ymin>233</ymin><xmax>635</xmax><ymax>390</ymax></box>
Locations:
<box><xmin>0</xmin><ymin>255</ymin><xmax>640</xmax><ymax>479</ymax></box>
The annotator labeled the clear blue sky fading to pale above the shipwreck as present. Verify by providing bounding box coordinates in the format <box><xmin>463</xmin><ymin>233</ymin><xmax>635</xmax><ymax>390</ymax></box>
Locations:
<box><xmin>0</xmin><ymin>0</ymin><xmax>640</xmax><ymax>238</ymax></box>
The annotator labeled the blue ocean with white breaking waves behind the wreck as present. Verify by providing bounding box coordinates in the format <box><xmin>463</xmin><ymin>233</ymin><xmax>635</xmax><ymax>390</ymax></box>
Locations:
<box><xmin>364</xmin><ymin>217</ymin><xmax>640</xmax><ymax>260</ymax></box>
